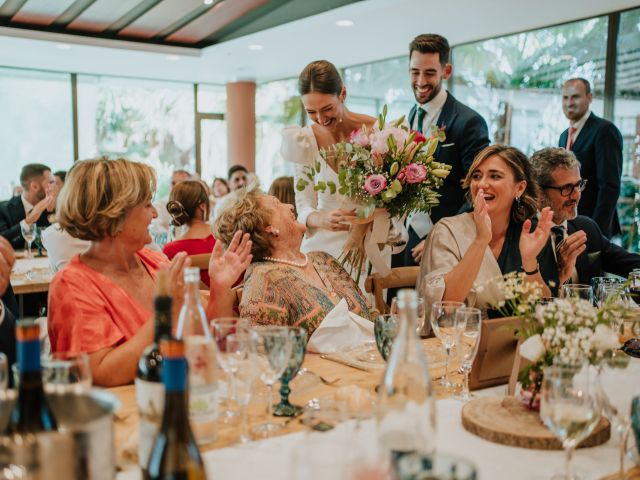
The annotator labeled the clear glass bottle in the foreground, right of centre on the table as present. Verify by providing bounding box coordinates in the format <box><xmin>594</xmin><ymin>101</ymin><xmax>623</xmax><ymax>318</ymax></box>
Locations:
<box><xmin>377</xmin><ymin>289</ymin><xmax>435</xmax><ymax>469</ymax></box>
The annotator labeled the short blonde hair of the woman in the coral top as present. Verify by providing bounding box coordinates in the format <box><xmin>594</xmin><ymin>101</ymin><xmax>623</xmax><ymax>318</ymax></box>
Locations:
<box><xmin>56</xmin><ymin>157</ymin><xmax>156</xmax><ymax>241</ymax></box>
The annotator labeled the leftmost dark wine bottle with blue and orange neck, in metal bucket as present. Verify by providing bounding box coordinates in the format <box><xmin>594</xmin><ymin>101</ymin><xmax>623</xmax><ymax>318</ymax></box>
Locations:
<box><xmin>6</xmin><ymin>319</ymin><xmax>58</xmax><ymax>435</ymax></box>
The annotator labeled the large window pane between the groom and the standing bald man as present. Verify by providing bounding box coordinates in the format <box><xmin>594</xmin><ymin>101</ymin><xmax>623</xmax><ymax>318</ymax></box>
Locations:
<box><xmin>453</xmin><ymin>16</ymin><xmax>607</xmax><ymax>154</ymax></box>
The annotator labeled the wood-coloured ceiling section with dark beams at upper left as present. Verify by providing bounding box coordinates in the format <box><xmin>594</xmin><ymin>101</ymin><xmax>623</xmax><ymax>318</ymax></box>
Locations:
<box><xmin>0</xmin><ymin>0</ymin><xmax>360</xmax><ymax>48</ymax></box>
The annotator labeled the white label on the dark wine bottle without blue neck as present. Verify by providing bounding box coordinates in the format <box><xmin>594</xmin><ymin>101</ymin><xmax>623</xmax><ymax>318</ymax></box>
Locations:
<box><xmin>136</xmin><ymin>378</ymin><xmax>164</xmax><ymax>468</ymax></box>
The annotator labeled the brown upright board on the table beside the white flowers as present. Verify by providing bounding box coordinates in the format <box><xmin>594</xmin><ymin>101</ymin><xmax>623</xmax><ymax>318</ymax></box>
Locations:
<box><xmin>469</xmin><ymin>317</ymin><xmax>520</xmax><ymax>390</ymax></box>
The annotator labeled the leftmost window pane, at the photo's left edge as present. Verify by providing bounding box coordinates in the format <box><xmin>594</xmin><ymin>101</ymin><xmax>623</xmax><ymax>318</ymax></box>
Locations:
<box><xmin>0</xmin><ymin>68</ymin><xmax>73</xmax><ymax>201</ymax></box>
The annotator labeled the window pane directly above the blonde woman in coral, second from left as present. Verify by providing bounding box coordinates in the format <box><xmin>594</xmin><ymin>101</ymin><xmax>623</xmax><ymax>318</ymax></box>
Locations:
<box><xmin>78</xmin><ymin>75</ymin><xmax>195</xmax><ymax>198</ymax></box>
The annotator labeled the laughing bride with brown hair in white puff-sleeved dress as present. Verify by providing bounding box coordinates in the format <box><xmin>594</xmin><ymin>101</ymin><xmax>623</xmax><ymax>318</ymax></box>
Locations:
<box><xmin>281</xmin><ymin>60</ymin><xmax>376</xmax><ymax>258</ymax></box>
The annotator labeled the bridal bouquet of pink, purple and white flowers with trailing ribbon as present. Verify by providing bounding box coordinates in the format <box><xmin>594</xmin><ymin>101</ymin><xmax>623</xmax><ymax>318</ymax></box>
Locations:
<box><xmin>296</xmin><ymin>105</ymin><xmax>451</xmax><ymax>278</ymax></box>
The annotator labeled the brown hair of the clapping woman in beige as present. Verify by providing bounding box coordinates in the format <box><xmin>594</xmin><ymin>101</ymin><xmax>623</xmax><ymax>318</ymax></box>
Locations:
<box><xmin>462</xmin><ymin>145</ymin><xmax>540</xmax><ymax>223</ymax></box>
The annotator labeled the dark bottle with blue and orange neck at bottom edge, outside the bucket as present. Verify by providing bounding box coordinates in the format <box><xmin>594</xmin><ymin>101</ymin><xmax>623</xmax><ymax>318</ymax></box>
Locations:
<box><xmin>145</xmin><ymin>339</ymin><xmax>206</xmax><ymax>480</ymax></box>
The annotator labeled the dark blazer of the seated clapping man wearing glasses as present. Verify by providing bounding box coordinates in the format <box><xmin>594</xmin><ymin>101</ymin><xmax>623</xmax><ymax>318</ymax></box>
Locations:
<box><xmin>567</xmin><ymin>215</ymin><xmax>640</xmax><ymax>285</ymax></box>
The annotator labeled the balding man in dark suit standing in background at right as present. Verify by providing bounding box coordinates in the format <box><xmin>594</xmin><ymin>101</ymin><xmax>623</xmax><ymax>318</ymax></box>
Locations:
<box><xmin>558</xmin><ymin>78</ymin><xmax>622</xmax><ymax>237</ymax></box>
